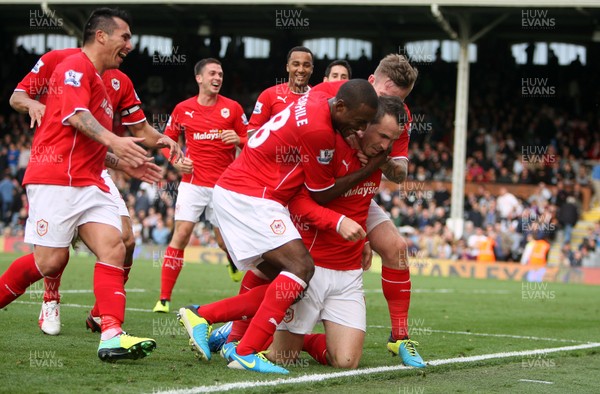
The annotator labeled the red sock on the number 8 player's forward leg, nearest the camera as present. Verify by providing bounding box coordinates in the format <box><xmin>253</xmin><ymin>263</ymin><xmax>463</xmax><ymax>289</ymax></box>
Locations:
<box><xmin>236</xmin><ymin>271</ymin><xmax>306</xmax><ymax>356</ymax></box>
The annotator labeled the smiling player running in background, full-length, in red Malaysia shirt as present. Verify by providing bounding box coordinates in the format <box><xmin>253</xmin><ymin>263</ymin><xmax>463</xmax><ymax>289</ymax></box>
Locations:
<box><xmin>154</xmin><ymin>58</ymin><xmax>248</xmax><ymax>312</ymax></box>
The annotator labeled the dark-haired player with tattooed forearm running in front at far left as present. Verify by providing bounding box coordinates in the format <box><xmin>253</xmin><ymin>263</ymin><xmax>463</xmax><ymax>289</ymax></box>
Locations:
<box><xmin>0</xmin><ymin>8</ymin><xmax>162</xmax><ymax>361</ymax></box>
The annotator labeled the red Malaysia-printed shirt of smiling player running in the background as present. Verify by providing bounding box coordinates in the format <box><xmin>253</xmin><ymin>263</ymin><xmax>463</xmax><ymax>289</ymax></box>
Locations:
<box><xmin>165</xmin><ymin>95</ymin><xmax>248</xmax><ymax>187</ymax></box>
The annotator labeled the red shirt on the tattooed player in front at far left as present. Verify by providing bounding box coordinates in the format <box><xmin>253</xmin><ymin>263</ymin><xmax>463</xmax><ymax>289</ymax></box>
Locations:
<box><xmin>23</xmin><ymin>53</ymin><xmax>113</xmax><ymax>192</ymax></box>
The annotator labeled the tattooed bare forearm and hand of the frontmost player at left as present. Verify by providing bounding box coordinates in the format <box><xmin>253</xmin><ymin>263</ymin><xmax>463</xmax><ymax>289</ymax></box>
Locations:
<box><xmin>67</xmin><ymin>111</ymin><xmax>148</xmax><ymax>167</ymax></box>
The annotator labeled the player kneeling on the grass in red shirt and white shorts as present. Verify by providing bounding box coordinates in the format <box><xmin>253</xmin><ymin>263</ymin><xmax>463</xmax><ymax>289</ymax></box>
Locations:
<box><xmin>266</xmin><ymin>96</ymin><xmax>405</xmax><ymax>368</ymax></box>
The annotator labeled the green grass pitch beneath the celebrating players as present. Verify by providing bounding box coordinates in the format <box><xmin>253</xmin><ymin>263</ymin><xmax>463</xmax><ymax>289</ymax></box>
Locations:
<box><xmin>0</xmin><ymin>254</ymin><xmax>600</xmax><ymax>394</ymax></box>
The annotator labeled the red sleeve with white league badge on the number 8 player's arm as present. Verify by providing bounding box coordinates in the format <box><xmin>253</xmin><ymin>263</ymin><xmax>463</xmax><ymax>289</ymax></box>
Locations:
<box><xmin>300</xmin><ymin>126</ymin><xmax>335</xmax><ymax>192</ymax></box>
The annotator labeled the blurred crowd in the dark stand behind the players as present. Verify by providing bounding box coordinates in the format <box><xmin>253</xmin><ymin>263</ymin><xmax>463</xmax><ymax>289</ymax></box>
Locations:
<box><xmin>0</xmin><ymin>41</ymin><xmax>600</xmax><ymax>266</ymax></box>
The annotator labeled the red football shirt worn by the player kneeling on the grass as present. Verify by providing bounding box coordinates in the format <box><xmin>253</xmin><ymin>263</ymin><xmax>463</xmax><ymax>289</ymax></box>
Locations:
<box><xmin>288</xmin><ymin>134</ymin><xmax>381</xmax><ymax>271</ymax></box>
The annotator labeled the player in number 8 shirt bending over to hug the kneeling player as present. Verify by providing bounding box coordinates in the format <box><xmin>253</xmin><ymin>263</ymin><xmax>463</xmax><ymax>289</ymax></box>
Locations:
<box><xmin>180</xmin><ymin>80</ymin><xmax>387</xmax><ymax>373</ymax></box>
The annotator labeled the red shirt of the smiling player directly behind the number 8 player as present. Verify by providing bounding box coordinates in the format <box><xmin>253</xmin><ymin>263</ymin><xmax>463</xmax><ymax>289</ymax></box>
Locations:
<box><xmin>248</xmin><ymin>83</ymin><xmax>306</xmax><ymax>130</ymax></box>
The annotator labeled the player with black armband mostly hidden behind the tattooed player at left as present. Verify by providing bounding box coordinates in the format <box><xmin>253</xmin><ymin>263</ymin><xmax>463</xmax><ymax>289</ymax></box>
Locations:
<box><xmin>10</xmin><ymin>42</ymin><xmax>183</xmax><ymax>335</ymax></box>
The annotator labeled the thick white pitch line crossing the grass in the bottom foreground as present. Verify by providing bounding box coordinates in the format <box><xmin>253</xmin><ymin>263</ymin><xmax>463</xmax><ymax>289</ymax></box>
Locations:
<box><xmin>153</xmin><ymin>343</ymin><xmax>600</xmax><ymax>394</ymax></box>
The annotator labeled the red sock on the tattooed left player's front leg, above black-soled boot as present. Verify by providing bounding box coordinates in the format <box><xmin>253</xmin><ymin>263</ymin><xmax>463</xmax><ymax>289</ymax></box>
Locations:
<box><xmin>94</xmin><ymin>261</ymin><xmax>126</xmax><ymax>332</ymax></box>
